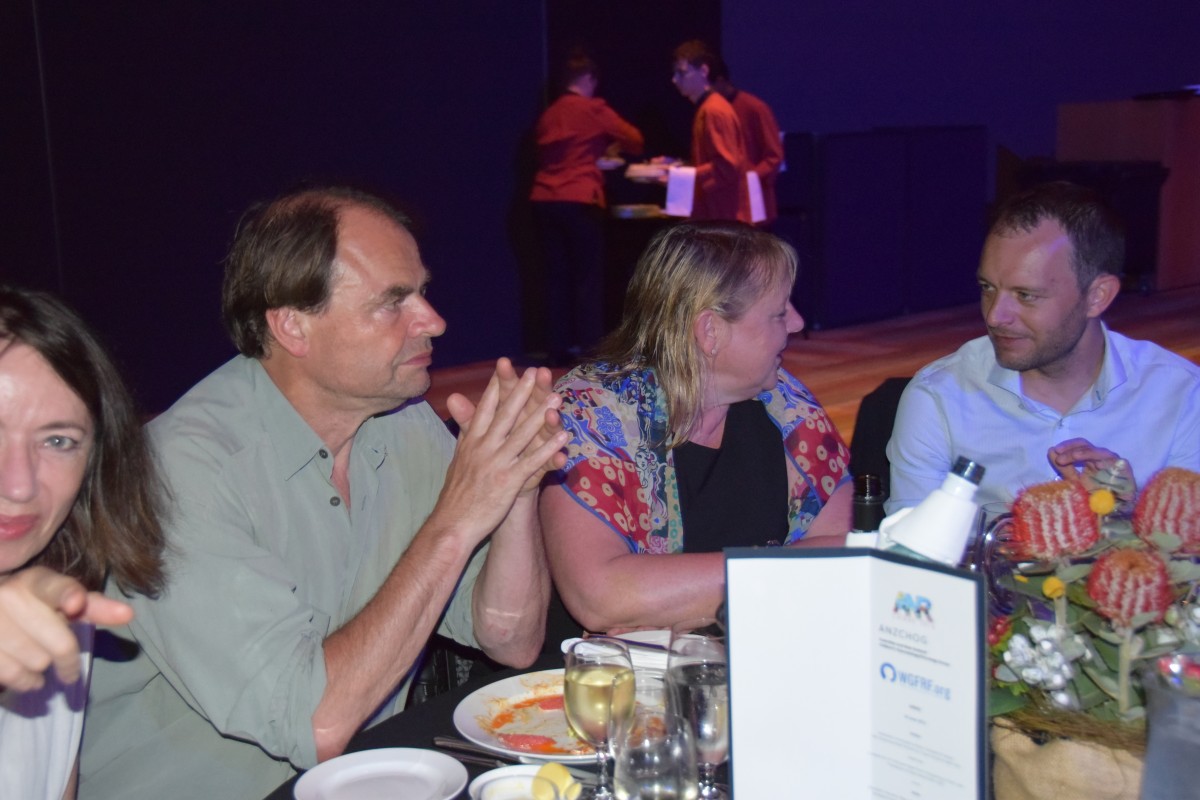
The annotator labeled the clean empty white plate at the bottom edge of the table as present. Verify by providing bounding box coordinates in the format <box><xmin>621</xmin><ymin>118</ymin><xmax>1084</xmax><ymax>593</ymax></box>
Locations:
<box><xmin>295</xmin><ymin>747</ymin><xmax>467</xmax><ymax>800</ymax></box>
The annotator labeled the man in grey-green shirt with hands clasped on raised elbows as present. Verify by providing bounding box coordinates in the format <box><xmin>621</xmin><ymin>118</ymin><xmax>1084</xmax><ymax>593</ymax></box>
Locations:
<box><xmin>80</xmin><ymin>190</ymin><xmax>565</xmax><ymax>799</ymax></box>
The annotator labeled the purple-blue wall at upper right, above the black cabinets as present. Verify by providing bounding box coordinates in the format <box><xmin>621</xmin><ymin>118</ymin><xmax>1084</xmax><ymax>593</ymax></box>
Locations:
<box><xmin>722</xmin><ymin>0</ymin><xmax>1200</xmax><ymax>158</ymax></box>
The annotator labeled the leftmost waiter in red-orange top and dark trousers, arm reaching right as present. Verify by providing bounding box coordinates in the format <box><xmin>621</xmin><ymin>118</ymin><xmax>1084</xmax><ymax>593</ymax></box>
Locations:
<box><xmin>529</xmin><ymin>54</ymin><xmax>644</xmax><ymax>362</ymax></box>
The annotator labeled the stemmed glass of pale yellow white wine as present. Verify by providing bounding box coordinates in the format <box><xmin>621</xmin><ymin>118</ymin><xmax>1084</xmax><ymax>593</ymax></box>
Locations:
<box><xmin>563</xmin><ymin>637</ymin><xmax>634</xmax><ymax>800</ymax></box>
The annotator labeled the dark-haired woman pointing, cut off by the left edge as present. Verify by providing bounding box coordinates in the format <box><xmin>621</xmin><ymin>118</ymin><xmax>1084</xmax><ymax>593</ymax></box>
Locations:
<box><xmin>0</xmin><ymin>287</ymin><xmax>163</xmax><ymax>800</ymax></box>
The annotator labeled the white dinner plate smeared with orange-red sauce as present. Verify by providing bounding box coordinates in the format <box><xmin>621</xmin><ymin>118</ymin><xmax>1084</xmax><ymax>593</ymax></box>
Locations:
<box><xmin>454</xmin><ymin>669</ymin><xmax>596</xmax><ymax>764</ymax></box>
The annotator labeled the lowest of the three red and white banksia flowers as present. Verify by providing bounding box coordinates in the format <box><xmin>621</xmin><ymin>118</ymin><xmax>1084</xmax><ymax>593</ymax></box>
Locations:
<box><xmin>1087</xmin><ymin>548</ymin><xmax>1174</xmax><ymax>628</ymax></box>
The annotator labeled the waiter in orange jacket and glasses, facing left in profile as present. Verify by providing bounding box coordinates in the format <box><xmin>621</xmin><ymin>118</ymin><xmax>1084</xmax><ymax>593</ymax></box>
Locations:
<box><xmin>671</xmin><ymin>40</ymin><xmax>750</xmax><ymax>222</ymax></box>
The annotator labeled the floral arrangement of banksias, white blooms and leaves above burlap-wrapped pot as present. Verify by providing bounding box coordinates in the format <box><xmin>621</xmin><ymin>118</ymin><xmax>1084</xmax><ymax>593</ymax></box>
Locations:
<box><xmin>985</xmin><ymin>462</ymin><xmax>1200</xmax><ymax>752</ymax></box>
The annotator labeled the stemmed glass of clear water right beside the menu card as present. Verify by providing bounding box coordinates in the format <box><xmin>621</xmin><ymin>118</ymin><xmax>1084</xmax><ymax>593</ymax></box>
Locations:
<box><xmin>667</xmin><ymin>618</ymin><xmax>730</xmax><ymax>800</ymax></box>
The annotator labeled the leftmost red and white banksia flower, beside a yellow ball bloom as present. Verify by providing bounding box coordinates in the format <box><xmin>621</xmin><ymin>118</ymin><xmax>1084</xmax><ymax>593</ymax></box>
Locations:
<box><xmin>1009</xmin><ymin>481</ymin><xmax>1100</xmax><ymax>561</ymax></box>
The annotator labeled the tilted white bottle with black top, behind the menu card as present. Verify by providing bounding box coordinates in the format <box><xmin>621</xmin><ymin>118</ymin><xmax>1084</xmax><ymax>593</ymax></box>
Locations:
<box><xmin>877</xmin><ymin>457</ymin><xmax>984</xmax><ymax>566</ymax></box>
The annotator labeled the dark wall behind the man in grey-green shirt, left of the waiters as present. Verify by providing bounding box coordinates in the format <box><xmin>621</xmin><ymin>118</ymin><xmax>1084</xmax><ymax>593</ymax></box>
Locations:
<box><xmin>0</xmin><ymin>0</ymin><xmax>542</xmax><ymax>410</ymax></box>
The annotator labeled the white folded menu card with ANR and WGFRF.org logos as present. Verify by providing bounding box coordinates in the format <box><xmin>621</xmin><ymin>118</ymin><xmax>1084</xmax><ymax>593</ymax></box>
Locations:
<box><xmin>725</xmin><ymin>547</ymin><xmax>988</xmax><ymax>800</ymax></box>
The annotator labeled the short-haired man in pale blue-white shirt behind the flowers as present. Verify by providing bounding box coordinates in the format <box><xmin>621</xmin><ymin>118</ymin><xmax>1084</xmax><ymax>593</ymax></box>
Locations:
<box><xmin>887</xmin><ymin>182</ymin><xmax>1200</xmax><ymax>512</ymax></box>
